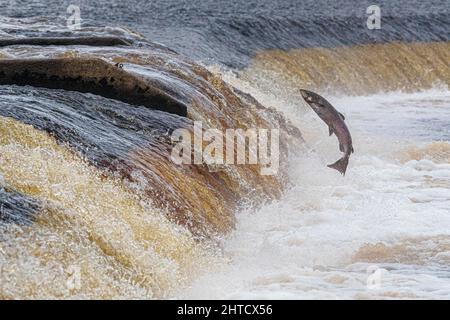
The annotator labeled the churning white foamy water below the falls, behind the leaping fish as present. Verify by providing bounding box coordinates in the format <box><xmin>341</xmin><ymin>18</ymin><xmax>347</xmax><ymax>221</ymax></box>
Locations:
<box><xmin>178</xmin><ymin>85</ymin><xmax>450</xmax><ymax>299</ymax></box>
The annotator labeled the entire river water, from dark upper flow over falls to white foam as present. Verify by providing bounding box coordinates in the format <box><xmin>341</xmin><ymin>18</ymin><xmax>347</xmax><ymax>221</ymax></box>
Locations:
<box><xmin>0</xmin><ymin>0</ymin><xmax>450</xmax><ymax>299</ymax></box>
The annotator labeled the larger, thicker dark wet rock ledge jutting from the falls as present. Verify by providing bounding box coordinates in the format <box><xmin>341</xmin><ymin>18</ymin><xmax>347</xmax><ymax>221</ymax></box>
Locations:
<box><xmin>0</xmin><ymin>57</ymin><xmax>187</xmax><ymax>116</ymax></box>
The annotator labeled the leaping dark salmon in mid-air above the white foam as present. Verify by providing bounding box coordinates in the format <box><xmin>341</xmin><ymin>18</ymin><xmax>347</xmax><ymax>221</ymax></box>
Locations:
<box><xmin>300</xmin><ymin>89</ymin><xmax>354</xmax><ymax>175</ymax></box>
